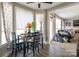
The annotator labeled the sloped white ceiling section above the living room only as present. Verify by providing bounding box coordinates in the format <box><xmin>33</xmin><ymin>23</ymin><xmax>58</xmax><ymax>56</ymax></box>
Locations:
<box><xmin>55</xmin><ymin>3</ymin><xmax>79</xmax><ymax>19</ymax></box>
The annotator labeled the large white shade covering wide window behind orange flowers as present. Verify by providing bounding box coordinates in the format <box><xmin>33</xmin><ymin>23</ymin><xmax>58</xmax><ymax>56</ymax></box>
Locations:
<box><xmin>15</xmin><ymin>6</ymin><xmax>33</xmax><ymax>35</ymax></box>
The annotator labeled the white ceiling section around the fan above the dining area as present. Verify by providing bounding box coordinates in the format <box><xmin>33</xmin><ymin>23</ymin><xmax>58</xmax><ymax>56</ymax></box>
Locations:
<box><xmin>18</xmin><ymin>2</ymin><xmax>62</xmax><ymax>10</ymax></box>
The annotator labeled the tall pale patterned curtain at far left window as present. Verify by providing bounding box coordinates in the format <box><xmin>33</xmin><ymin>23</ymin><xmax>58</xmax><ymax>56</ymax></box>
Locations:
<box><xmin>1</xmin><ymin>2</ymin><xmax>13</xmax><ymax>44</ymax></box>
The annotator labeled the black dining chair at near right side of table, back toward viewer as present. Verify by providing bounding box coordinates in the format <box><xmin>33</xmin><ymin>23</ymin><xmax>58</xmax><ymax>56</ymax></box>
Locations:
<box><xmin>27</xmin><ymin>32</ymin><xmax>40</xmax><ymax>56</ymax></box>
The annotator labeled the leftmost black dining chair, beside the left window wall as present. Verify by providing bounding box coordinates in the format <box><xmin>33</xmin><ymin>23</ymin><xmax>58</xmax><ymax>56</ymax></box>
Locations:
<box><xmin>11</xmin><ymin>32</ymin><xmax>23</xmax><ymax>57</ymax></box>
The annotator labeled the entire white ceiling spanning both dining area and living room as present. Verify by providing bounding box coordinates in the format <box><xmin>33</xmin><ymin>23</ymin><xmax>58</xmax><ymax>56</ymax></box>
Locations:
<box><xmin>18</xmin><ymin>2</ymin><xmax>79</xmax><ymax>19</ymax></box>
